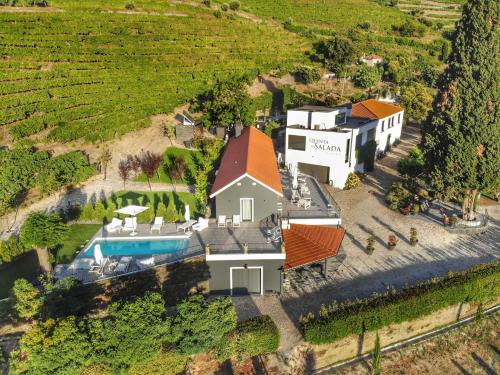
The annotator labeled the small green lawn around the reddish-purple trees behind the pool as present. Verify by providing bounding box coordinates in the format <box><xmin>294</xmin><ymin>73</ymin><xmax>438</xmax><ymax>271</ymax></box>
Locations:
<box><xmin>135</xmin><ymin>147</ymin><xmax>203</xmax><ymax>185</ymax></box>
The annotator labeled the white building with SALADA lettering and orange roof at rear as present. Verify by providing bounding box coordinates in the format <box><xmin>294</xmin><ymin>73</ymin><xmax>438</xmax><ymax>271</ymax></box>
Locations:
<box><xmin>285</xmin><ymin>99</ymin><xmax>404</xmax><ymax>188</ymax></box>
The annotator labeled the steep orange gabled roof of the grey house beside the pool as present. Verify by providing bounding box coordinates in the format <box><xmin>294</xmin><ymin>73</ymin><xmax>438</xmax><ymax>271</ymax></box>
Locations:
<box><xmin>210</xmin><ymin>127</ymin><xmax>283</xmax><ymax>198</ymax></box>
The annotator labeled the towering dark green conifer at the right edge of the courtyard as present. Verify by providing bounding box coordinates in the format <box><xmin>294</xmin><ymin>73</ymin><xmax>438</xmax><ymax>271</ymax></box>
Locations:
<box><xmin>422</xmin><ymin>0</ymin><xmax>500</xmax><ymax>220</ymax></box>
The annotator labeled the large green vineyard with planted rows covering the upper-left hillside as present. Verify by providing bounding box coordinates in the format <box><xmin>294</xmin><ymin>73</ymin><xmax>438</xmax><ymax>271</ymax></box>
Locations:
<box><xmin>0</xmin><ymin>0</ymin><xmax>310</xmax><ymax>143</ymax></box>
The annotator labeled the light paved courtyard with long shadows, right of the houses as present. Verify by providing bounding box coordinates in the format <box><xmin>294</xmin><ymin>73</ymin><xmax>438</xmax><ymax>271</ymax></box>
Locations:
<box><xmin>233</xmin><ymin>127</ymin><xmax>500</xmax><ymax>352</ymax></box>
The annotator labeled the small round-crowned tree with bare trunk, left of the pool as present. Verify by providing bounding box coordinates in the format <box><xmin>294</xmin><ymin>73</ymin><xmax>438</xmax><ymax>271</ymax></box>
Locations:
<box><xmin>19</xmin><ymin>212</ymin><xmax>68</xmax><ymax>272</ymax></box>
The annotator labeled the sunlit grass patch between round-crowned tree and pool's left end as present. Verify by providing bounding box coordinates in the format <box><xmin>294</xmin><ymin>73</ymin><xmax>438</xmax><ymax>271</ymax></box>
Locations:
<box><xmin>56</xmin><ymin>224</ymin><xmax>101</xmax><ymax>264</ymax></box>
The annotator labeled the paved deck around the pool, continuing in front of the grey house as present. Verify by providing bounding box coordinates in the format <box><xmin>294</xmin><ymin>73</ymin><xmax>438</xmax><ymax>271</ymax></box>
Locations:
<box><xmin>54</xmin><ymin>220</ymin><xmax>281</xmax><ymax>283</ymax></box>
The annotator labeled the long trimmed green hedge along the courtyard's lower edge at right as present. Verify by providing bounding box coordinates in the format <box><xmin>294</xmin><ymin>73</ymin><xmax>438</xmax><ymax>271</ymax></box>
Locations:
<box><xmin>302</xmin><ymin>261</ymin><xmax>500</xmax><ymax>344</ymax></box>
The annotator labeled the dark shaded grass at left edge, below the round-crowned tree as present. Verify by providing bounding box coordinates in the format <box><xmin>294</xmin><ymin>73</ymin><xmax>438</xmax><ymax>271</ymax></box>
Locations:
<box><xmin>0</xmin><ymin>251</ymin><xmax>40</xmax><ymax>299</ymax></box>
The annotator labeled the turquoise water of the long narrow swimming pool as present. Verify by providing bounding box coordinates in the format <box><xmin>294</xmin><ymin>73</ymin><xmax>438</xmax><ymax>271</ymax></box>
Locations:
<box><xmin>82</xmin><ymin>238</ymin><xmax>189</xmax><ymax>257</ymax></box>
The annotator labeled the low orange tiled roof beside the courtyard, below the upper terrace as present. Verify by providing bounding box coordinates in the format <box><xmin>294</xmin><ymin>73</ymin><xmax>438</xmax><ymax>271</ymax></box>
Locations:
<box><xmin>283</xmin><ymin>224</ymin><xmax>345</xmax><ymax>269</ymax></box>
